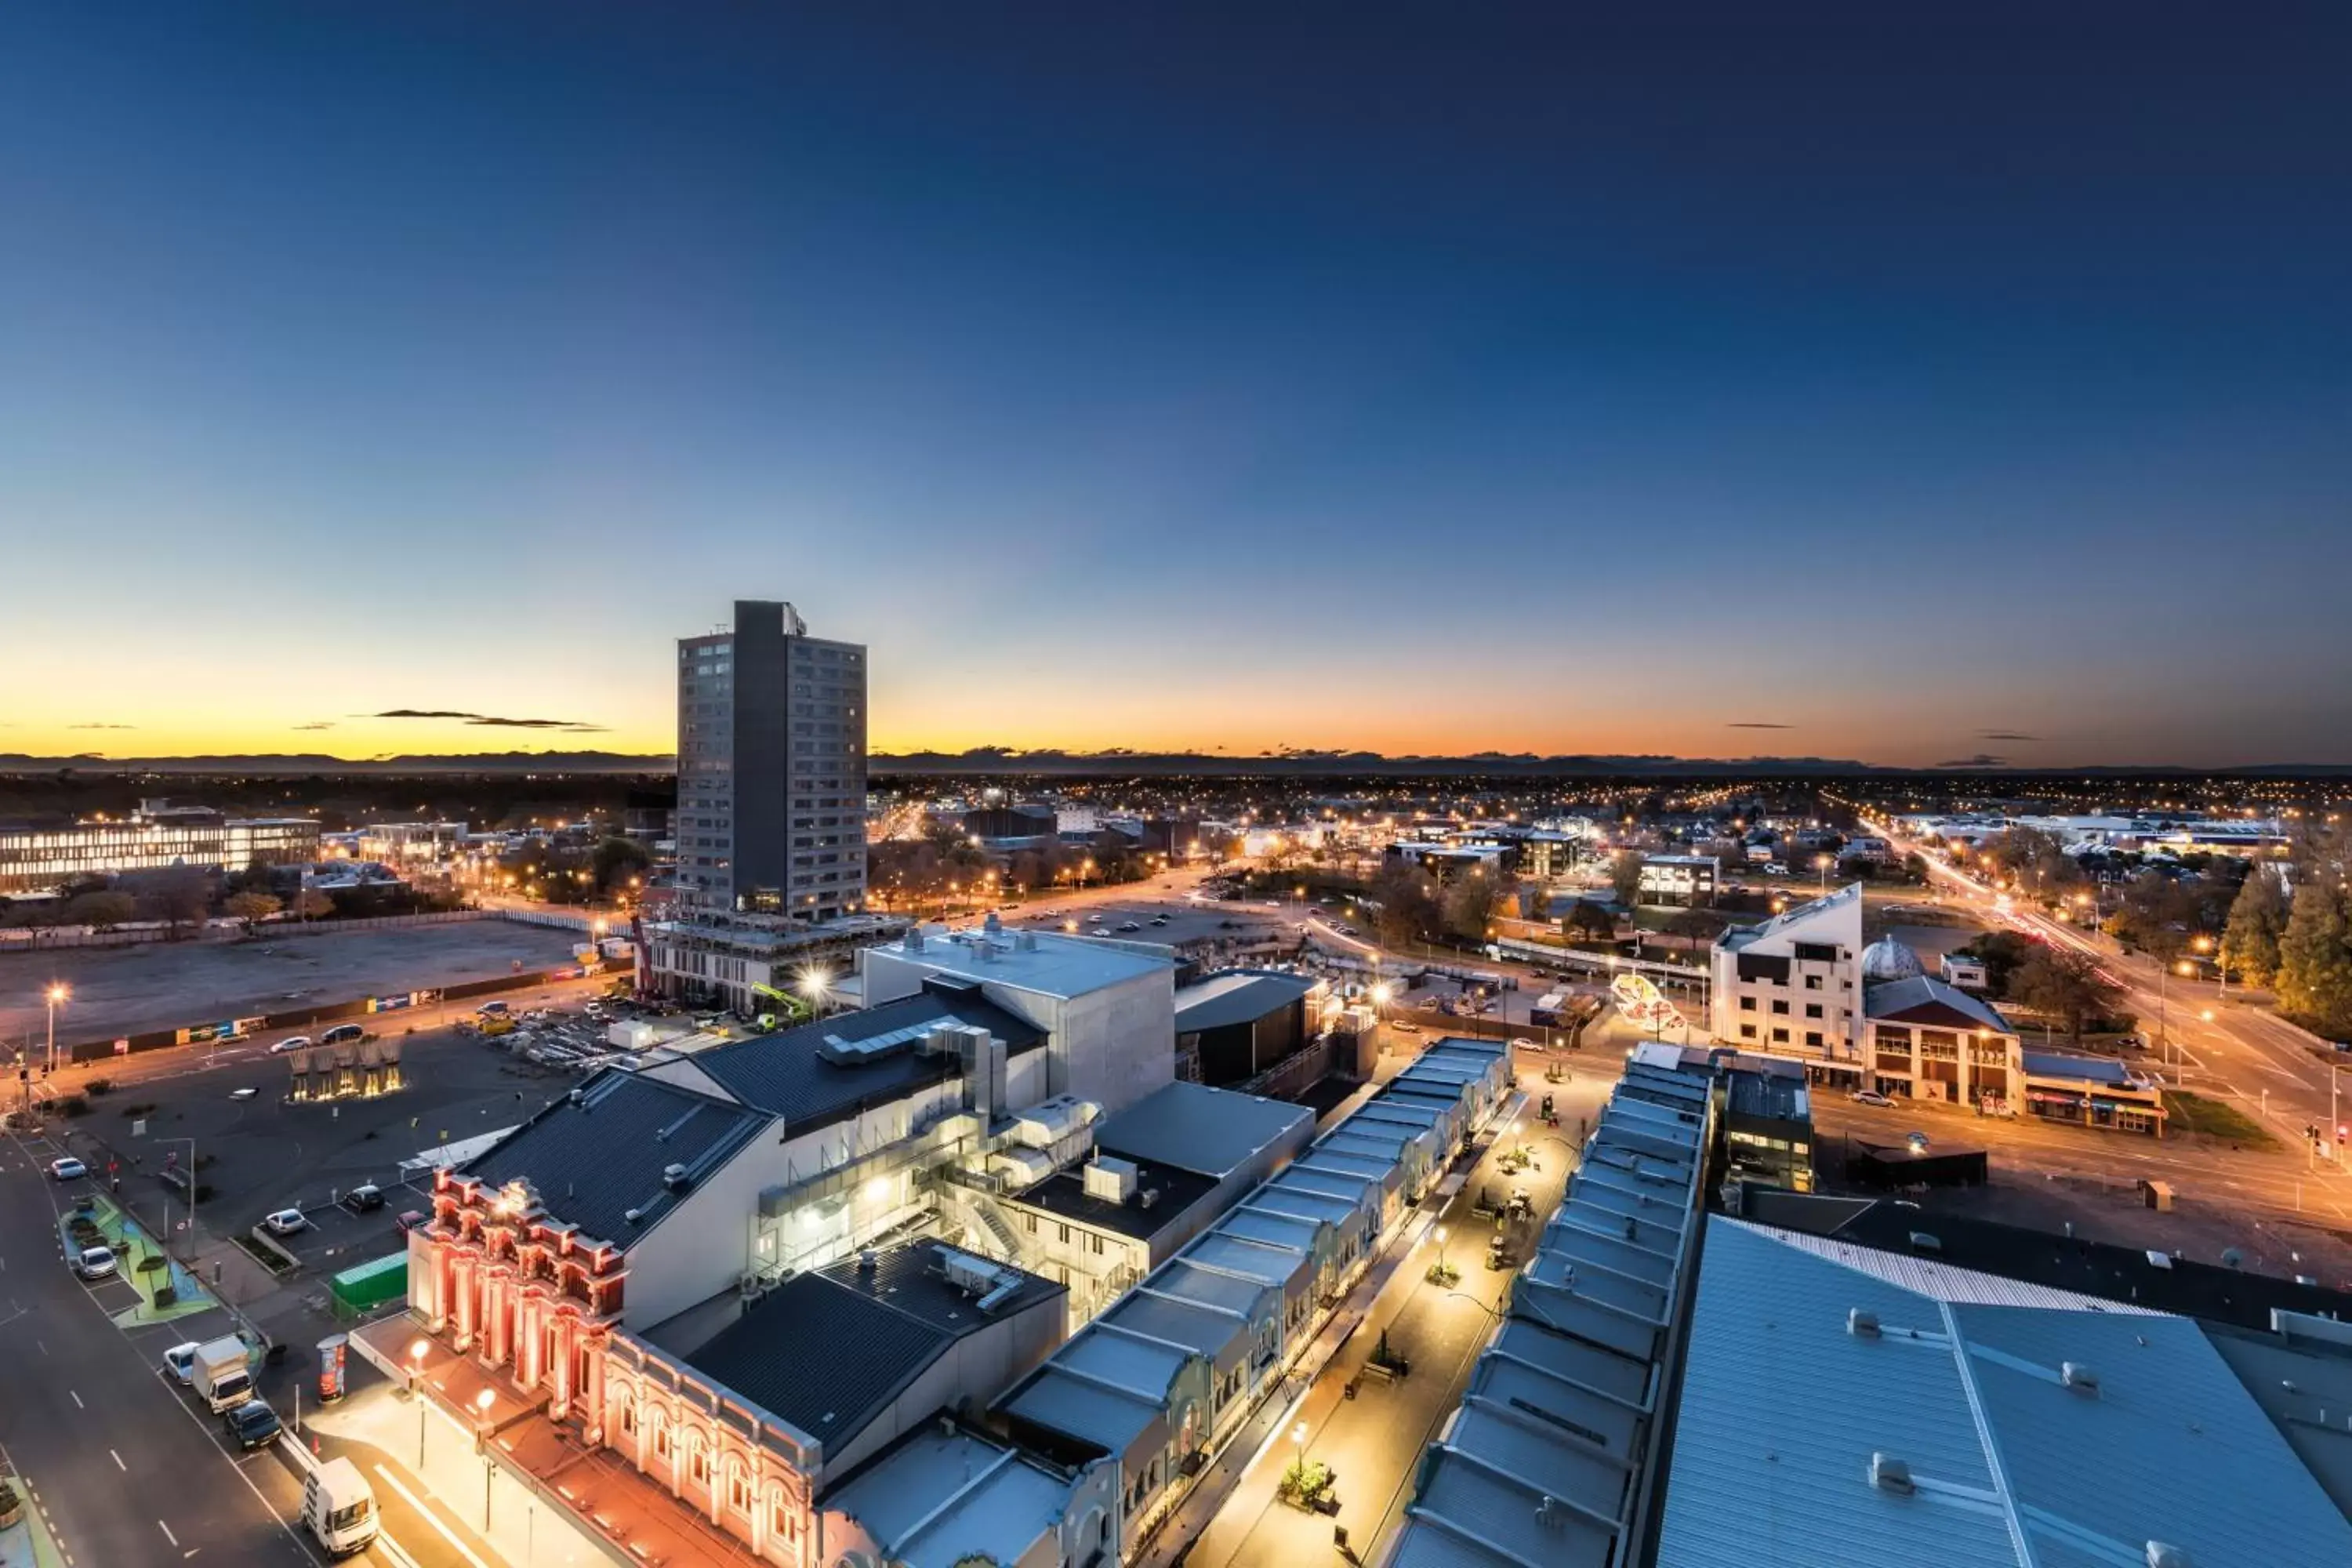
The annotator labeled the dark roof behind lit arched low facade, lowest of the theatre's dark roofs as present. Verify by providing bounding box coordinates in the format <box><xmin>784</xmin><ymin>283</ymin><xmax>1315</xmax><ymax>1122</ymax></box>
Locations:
<box><xmin>687</xmin><ymin>1241</ymin><xmax>1063</xmax><ymax>1446</ymax></box>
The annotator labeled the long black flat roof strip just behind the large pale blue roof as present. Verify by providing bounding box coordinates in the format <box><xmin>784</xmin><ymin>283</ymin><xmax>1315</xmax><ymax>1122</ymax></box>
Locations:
<box><xmin>1825</xmin><ymin>1199</ymin><xmax>2352</xmax><ymax>1328</ymax></box>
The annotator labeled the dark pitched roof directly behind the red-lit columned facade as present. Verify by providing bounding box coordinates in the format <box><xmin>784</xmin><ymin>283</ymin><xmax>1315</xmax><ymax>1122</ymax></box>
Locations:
<box><xmin>466</xmin><ymin>1072</ymin><xmax>769</xmax><ymax>1248</ymax></box>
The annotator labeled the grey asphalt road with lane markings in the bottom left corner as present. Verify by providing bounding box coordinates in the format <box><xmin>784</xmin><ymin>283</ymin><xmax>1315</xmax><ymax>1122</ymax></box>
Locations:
<box><xmin>0</xmin><ymin>1138</ymin><xmax>315</xmax><ymax>1568</ymax></box>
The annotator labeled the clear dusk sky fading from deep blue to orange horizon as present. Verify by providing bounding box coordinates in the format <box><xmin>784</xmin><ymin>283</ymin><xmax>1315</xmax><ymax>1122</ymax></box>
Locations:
<box><xmin>0</xmin><ymin>0</ymin><xmax>2352</xmax><ymax>767</ymax></box>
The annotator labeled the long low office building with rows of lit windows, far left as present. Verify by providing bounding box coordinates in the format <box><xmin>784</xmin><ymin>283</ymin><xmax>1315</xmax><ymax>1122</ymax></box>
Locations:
<box><xmin>0</xmin><ymin>799</ymin><xmax>318</xmax><ymax>893</ymax></box>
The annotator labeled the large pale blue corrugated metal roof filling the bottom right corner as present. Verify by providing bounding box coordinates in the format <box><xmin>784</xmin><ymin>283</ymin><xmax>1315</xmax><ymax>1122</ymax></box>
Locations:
<box><xmin>1658</xmin><ymin>1218</ymin><xmax>2352</xmax><ymax>1568</ymax></box>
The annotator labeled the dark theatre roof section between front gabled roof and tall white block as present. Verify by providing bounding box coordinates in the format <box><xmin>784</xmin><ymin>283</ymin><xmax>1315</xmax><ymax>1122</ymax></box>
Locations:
<box><xmin>694</xmin><ymin>978</ymin><xmax>1044</xmax><ymax>1133</ymax></box>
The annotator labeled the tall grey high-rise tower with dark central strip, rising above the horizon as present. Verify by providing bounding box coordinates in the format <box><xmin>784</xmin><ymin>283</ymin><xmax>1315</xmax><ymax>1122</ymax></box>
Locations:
<box><xmin>675</xmin><ymin>600</ymin><xmax>866</xmax><ymax>921</ymax></box>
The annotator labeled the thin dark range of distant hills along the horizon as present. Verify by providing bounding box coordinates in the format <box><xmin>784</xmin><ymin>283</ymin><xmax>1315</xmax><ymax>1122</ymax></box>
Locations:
<box><xmin>0</xmin><ymin>746</ymin><xmax>2352</xmax><ymax>779</ymax></box>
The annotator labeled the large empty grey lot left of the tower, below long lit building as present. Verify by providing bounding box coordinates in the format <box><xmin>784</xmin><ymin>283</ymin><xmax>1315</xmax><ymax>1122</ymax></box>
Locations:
<box><xmin>0</xmin><ymin>919</ymin><xmax>588</xmax><ymax>1044</ymax></box>
